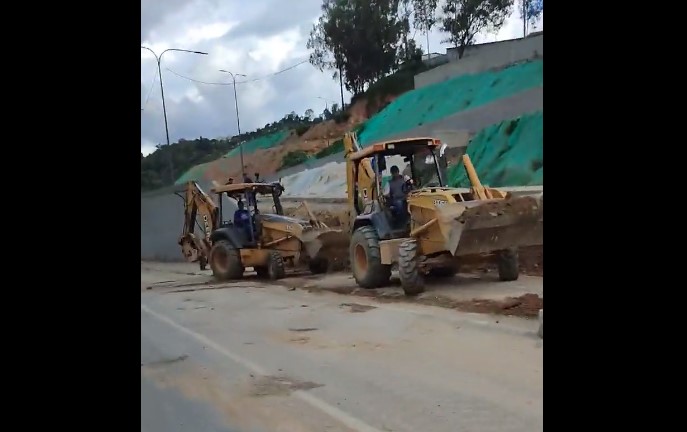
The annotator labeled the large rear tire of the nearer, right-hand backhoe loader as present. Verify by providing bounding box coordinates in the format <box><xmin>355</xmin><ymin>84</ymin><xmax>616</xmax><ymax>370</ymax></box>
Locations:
<box><xmin>350</xmin><ymin>226</ymin><xmax>391</xmax><ymax>289</ymax></box>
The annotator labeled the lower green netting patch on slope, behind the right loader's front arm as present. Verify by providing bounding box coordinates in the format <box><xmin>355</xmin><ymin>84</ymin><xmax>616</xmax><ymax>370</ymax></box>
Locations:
<box><xmin>448</xmin><ymin>111</ymin><xmax>544</xmax><ymax>187</ymax></box>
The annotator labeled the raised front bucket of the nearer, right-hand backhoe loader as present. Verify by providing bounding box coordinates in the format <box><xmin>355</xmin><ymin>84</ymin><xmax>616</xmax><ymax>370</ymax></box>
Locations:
<box><xmin>437</xmin><ymin>193</ymin><xmax>544</xmax><ymax>256</ymax></box>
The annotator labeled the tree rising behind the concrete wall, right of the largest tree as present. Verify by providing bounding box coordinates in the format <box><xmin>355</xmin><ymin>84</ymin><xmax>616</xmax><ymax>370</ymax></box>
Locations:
<box><xmin>441</xmin><ymin>0</ymin><xmax>514</xmax><ymax>59</ymax></box>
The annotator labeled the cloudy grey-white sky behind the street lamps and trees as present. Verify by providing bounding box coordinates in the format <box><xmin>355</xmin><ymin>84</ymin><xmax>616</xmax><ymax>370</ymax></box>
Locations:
<box><xmin>141</xmin><ymin>0</ymin><xmax>543</xmax><ymax>154</ymax></box>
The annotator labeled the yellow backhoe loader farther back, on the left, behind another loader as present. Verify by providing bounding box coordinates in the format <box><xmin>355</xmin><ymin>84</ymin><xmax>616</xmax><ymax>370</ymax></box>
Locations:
<box><xmin>179</xmin><ymin>181</ymin><xmax>349</xmax><ymax>280</ymax></box>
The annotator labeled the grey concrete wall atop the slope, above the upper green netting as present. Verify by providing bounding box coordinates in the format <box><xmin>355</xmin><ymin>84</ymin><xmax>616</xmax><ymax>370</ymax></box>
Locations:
<box><xmin>415</xmin><ymin>33</ymin><xmax>544</xmax><ymax>89</ymax></box>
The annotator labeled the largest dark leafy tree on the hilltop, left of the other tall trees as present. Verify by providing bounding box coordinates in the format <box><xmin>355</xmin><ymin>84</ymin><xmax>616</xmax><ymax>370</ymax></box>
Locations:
<box><xmin>307</xmin><ymin>0</ymin><xmax>401</xmax><ymax>99</ymax></box>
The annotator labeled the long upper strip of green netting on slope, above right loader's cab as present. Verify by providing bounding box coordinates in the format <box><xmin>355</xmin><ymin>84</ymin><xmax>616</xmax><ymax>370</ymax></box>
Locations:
<box><xmin>358</xmin><ymin>60</ymin><xmax>544</xmax><ymax>146</ymax></box>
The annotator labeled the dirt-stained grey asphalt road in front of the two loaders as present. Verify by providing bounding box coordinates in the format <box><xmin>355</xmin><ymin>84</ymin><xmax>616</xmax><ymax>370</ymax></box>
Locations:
<box><xmin>141</xmin><ymin>267</ymin><xmax>543</xmax><ymax>432</ymax></box>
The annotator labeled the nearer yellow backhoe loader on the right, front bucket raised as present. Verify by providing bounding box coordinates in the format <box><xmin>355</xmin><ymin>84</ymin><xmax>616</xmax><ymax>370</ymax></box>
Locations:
<box><xmin>344</xmin><ymin>133</ymin><xmax>544</xmax><ymax>295</ymax></box>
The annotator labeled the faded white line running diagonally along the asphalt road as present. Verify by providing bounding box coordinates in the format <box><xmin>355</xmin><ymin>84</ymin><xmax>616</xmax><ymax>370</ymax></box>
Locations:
<box><xmin>141</xmin><ymin>305</ymin><xmax>382</xmax><ymax>432</ymax></box>
